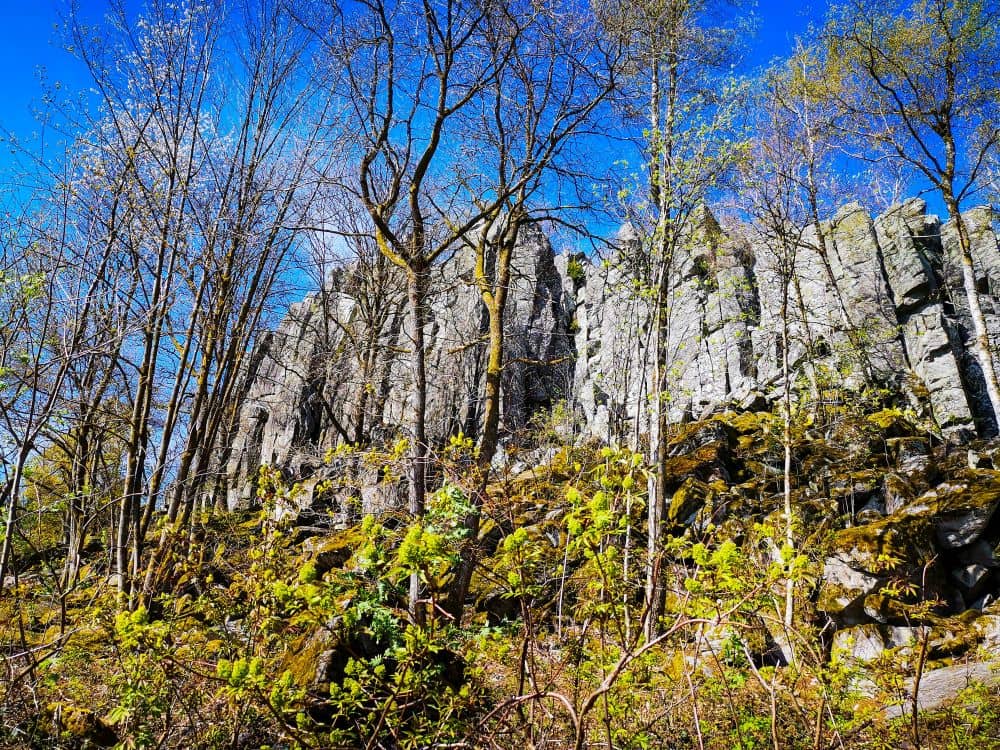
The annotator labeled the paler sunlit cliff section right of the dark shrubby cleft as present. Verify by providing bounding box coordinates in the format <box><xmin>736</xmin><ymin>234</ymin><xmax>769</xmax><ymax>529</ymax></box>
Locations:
<box><xmin>574</xmin><ymin>199</ymin><xmax>1000</xmax><ymax>441</ymax></box>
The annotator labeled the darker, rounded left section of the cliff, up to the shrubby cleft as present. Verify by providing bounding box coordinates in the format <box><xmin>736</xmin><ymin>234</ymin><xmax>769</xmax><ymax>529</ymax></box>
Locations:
<box><xmin>226</xmin><ymin>227</ymin><xmax>575</xmax><ymax>512</ymax></box>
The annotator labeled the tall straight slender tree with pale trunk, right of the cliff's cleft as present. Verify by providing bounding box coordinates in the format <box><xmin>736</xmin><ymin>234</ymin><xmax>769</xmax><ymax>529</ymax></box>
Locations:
<box><xmin>603</xmin><ymin>0</ymin><xmax>737</xmax><ymax>637</ymax></box>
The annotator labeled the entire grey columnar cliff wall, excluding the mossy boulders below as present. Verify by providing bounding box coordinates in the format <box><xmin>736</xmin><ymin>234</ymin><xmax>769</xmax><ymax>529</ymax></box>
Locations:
<box><xmin>227</xmin><ymin>200</ymin><xmax>1000</xmax><ymax>507</ymax></box>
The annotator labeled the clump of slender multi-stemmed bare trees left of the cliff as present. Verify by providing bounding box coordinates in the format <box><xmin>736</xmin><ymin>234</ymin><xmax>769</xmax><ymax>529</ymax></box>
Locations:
<box><xmin>43</xmin><ymin>0</ymin><xmax>329</xmax><ymax>603</ymax></box>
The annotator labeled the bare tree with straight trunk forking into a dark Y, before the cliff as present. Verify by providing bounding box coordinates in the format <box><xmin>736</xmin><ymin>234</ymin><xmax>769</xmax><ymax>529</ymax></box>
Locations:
<box><xmin>316</xmin><ymin>0</ymin><xmax>509</xmax><ymax>622</ymax></box>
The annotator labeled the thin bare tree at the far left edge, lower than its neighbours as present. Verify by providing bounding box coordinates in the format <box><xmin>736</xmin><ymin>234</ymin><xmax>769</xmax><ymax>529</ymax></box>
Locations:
<box><xmin>0</xmin><ymin>169</ymin><xmax>124</xmax><ymax>587</ymax></box>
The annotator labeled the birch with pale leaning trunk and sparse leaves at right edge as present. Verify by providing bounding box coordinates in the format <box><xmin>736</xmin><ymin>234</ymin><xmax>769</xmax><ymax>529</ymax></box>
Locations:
<box><xmin>824</xmin><ymin>0</ymin><xmax>1000</xmax><ymax>430</ymax></box>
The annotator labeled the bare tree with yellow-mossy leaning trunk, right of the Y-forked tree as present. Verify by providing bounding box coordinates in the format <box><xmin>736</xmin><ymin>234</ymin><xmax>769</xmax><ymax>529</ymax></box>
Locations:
<box><xmin>440</xmin><ymin>3</ymin><xmax>623</xmax><ymax>620</ymax></box>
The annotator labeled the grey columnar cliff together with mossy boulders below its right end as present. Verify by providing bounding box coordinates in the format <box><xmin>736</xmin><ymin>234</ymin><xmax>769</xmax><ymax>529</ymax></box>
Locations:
<box><xmin>219</xmin><ymin>200</ymin><xmax>1000</xmax><ymax>688</ymax></box>
